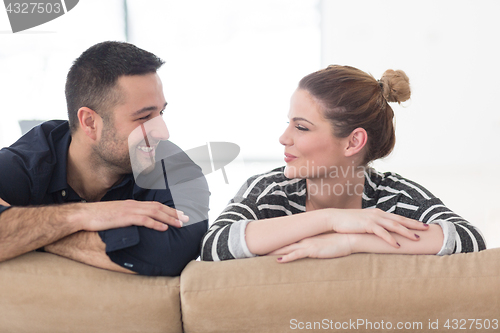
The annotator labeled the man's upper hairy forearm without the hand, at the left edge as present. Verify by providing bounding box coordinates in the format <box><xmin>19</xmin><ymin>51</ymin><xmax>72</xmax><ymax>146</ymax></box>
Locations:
<box><xmin>0</xmin><ymin>204</ymin><xmax>80</xmax><ymax>261</ymax></box>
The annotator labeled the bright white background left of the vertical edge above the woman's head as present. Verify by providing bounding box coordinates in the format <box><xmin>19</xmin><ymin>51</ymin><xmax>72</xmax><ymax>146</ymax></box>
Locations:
<box><xmin>0</xmin><ymin>0</ymin><xmax>321</xmax><ymax>221</ymax></box>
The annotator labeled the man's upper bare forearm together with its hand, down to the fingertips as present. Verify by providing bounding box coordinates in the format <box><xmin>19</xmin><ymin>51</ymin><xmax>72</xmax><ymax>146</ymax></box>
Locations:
<box><xmin>0</xmin><ymin>200</ymin><xmax>189</xmax><ymax>262</ymax></box>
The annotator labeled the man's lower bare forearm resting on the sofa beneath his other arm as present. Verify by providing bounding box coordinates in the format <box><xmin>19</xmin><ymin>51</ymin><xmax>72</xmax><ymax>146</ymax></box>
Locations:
<box><xmin>44</xmin><ymin>231</ymin><xmax>134</xmax><ymax>273</ymax></box>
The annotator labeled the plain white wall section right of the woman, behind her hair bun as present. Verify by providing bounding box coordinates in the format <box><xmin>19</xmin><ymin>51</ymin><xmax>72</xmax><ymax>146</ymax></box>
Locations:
<box><xmin>321</xmin><ymin>0</ymin><xmax>500</xmax><ymax>247</ymax></box>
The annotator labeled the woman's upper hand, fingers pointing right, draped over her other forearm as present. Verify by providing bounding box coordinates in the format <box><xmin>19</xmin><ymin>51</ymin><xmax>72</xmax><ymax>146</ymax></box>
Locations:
<box><xmin>327</xmin><ymin>208</ymin><xmax>429</xmax><ymax>248</ymax></box>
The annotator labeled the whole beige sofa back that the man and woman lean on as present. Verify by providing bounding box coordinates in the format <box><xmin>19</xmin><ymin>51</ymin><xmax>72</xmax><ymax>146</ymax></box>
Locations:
<box><xmin>0</xmin><ymin>249</ymin><xmax>500</xmax><ymax>333</ymax></box>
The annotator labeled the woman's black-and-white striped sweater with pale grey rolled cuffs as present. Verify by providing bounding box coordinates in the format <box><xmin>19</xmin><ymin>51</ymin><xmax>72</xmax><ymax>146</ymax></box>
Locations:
<box><xmin>201</xmin><ymin>167</ymin><xmax>486</xmax><ymax>261</ymax></box>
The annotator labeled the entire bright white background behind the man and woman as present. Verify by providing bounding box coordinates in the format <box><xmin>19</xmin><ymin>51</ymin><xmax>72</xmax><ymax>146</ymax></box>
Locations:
<box><xmin>0</xmin><ymin>0</ymin><xmax>500</xmax><ymax>247</ymax></box>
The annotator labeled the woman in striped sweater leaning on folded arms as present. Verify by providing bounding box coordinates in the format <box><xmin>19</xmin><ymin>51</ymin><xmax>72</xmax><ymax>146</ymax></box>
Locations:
<box><xmin>202</xmin><ymin>65</ymin><xmax>485</xmax><ymax>262</ymax></box>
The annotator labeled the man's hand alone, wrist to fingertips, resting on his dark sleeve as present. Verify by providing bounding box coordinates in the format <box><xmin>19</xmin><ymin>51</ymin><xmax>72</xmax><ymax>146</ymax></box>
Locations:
<box><xmin>78</xmin><ymin>200</ymin><xmax>189</xmax><ymax>231</ymax></box>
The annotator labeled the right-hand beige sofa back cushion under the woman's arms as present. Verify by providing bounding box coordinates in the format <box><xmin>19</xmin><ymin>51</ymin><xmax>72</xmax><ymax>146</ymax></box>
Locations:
<box><xmin>181</xmin><ymin>249</ymin><xmax>500</xmax><ymax>332</ymax></box>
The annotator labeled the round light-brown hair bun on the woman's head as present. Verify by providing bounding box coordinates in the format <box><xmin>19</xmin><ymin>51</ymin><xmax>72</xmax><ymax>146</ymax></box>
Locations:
<box><xmin>379</xmin><ymin>69</ymin><xmax>411</xmax><ymax>103</ymax></box>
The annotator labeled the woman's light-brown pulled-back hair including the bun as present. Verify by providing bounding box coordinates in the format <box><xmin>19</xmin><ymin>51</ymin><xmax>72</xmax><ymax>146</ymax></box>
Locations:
<box><xmin>299</xmin><ymin>65</ymin><xmax>411</xmax><ymax>165</ymax></box>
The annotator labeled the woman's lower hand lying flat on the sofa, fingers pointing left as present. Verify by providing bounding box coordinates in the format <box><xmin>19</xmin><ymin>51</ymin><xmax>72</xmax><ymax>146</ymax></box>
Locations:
<box><xmin>269</xmin><ymin>233</ymin><xmax>352</xmax><ymax>263</ymax></box>
